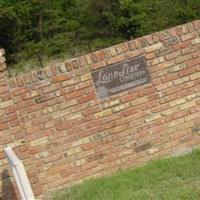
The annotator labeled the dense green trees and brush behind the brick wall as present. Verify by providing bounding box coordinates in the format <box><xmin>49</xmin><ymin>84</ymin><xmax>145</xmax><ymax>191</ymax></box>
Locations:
<box><xmin>0</xmin><ymin>0</ymin><xmax>200</xmax><ymax>72</ymax></box>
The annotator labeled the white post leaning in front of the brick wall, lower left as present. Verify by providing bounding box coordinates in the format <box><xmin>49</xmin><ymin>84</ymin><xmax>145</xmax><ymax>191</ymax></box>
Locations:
<box><xmin>4</xmin><ymin>147</ymin><xmax>35</xmax><ymax>200</ymax></box>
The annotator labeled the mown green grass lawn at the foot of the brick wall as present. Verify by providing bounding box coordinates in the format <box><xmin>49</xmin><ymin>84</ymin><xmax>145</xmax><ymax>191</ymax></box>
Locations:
<box><xmin>52</xmin><ymin>150</ymin><xmax>200</xmax><ymax>200</ymax></box>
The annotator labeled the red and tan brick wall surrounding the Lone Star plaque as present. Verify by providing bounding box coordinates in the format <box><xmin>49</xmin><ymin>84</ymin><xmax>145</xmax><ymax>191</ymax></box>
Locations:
<box><xmin>0</xmin><ymin>20</ymin><xmax>200</xmax><ymax>197</ymax></box>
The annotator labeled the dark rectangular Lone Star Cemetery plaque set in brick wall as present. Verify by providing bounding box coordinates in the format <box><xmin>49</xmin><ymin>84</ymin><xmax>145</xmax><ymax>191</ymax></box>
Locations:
<box><xmin>92</xmin><ymin>56</ymin><xmax>149</xmax><ymax>98</ymax></box>
